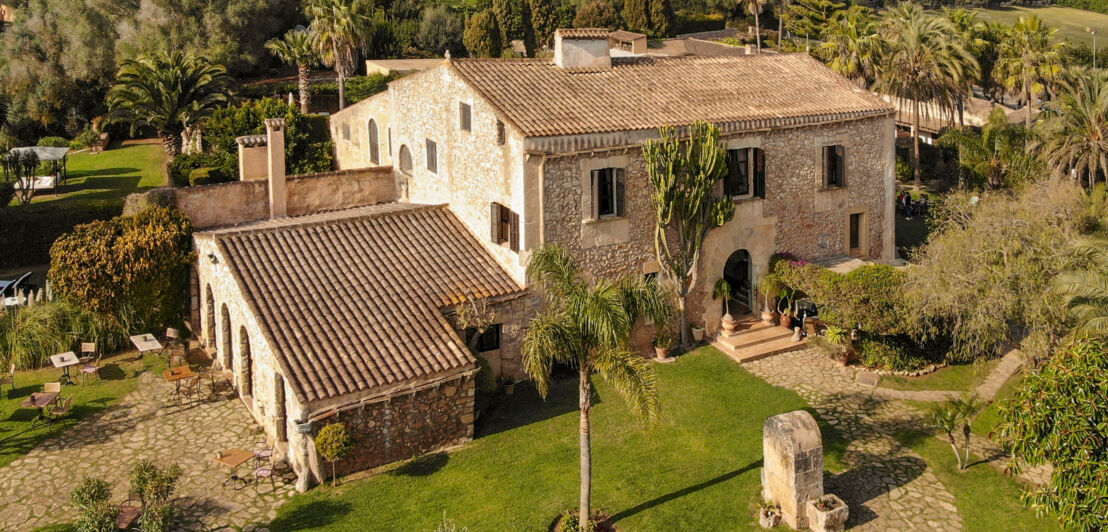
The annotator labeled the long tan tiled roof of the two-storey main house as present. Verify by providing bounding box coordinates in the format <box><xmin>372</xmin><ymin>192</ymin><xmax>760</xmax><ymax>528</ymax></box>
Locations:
<box><xmin>452</xmin><ymin>53</ymin><xmax>892</xmax><ymax>136</ymax></box>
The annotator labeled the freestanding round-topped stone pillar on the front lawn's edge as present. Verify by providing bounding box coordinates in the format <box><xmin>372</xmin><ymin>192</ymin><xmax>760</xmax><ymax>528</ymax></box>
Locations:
<box><xmin>762</xmin><ymin>410</ymin><xmax>823</xmax><ymax>529</ymax></box>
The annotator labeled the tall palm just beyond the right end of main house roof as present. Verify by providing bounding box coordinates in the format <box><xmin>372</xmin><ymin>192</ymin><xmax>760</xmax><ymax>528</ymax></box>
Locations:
<box><xmin>876</xmin><ymin>3</ymin><xmax>977</xmax><ymax>188</ymax></box>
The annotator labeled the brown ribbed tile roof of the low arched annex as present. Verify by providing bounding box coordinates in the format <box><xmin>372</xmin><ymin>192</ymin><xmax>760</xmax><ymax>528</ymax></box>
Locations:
<box><xmin>197</xmin><ymin>203</ymin><xmax>522</xmax><ymax>401</ymax></box>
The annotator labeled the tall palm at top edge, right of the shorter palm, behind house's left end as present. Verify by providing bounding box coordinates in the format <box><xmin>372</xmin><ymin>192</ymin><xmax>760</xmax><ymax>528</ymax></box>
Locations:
<box><xmin>304</xmin><ymin>0</ymin><xmax>377</xmax><ymax>110</ymax></box>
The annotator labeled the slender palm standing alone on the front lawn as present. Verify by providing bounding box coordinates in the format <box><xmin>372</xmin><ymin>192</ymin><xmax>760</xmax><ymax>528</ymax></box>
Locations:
<box><xmin>523</xmin><ymin>246</ymin><xmax>673</xmax><ymax>523</ymax></box>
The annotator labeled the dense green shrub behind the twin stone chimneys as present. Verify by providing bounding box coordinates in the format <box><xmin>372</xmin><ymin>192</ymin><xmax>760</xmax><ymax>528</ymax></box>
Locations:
<box><xmin>204</xmin><ymin>99</ymin><xmax>331</xmax><ymax>175</ymax></box>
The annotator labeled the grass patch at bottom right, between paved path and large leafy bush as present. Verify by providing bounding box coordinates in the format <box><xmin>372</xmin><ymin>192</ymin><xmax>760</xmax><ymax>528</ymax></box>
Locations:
<box><xmin>897</xmin><ymin>432</ymin><xmax>1060</xmax><ymax>532</ymax></box>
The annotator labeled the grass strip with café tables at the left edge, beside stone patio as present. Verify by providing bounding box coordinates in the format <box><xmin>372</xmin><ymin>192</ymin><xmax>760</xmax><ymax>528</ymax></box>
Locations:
<box><xmin>0</xmin><ymin>352</ymin><xmax>165</xmax><ymax>468</ymax></box>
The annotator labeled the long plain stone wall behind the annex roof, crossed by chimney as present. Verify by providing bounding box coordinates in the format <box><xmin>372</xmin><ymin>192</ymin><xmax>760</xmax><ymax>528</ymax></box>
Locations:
<box><xmin>134</xmin><ymin>166</ymin><xmax>397</xmax><ymax>229</ymax></box>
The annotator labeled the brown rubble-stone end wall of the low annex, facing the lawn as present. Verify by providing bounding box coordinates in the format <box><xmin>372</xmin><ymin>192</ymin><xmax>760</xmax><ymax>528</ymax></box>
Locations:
<box><xmin>311</xmin><ymin>376</ymin><xmax>474</xmax><ymax>474</ymax></box>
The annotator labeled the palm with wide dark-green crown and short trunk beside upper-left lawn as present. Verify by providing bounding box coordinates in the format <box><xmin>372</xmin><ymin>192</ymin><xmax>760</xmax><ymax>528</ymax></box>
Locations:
<box><xmin>106</xmin><ymin>51</ymin><xmax>230</xmax><ymax>156</ymax></box>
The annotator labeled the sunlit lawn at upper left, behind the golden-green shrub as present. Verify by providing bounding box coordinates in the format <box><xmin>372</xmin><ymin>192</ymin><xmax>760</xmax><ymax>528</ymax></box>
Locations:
<box><xmin>19</xmin><ymin>141</ymin><xmax>165</xmax><ymax>205</ymax></box>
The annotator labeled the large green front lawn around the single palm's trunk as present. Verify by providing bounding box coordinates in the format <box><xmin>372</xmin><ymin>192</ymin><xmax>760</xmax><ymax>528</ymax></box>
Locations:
<box><xmin>270</xmin><ymin>348</ymin><xmax>843</xmax><ymax>532</ymax></box>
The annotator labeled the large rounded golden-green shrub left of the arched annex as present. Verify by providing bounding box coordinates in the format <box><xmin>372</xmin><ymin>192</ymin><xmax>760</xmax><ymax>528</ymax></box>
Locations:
<box><xmin>49</xmin><ymin>207</ymin><xmax>193</xmax><ymax>328</ymax></box>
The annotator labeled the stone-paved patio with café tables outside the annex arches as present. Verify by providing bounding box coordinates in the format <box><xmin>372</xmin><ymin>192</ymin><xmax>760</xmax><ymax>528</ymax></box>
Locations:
<box><xmin>0</xmin><ymin>372</ymin><xmax>294</xmax><ymax>530</ymax></box>
